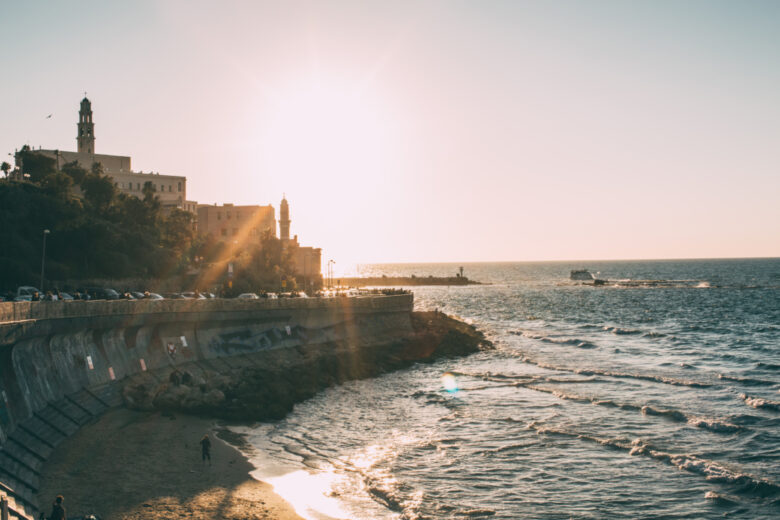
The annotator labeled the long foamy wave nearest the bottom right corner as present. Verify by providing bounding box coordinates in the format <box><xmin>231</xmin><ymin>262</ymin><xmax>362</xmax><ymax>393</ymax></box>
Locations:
<box><xmin>528</xmin><ymin>424</ymin><xmax>780</xmax><ymax>497</ymax></box>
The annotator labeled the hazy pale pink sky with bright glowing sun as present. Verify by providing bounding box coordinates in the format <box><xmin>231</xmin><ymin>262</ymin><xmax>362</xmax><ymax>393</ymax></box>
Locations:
<box><xmin>0</xmin><ymin>0</ymin><xmax>780</xmax><ymax>265</ymax></box>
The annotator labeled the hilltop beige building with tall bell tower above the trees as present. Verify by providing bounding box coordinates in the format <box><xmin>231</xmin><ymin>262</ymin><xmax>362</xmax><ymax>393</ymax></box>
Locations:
<box><xmin>16</xmin><ymin>98</ymin><xmax>189</xmax><ymax>213</ymax></box>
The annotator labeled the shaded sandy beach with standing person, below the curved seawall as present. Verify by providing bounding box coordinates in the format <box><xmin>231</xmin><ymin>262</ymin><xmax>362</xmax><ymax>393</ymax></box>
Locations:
<box><xmin>38</xmin><ymin>409</ymin><xmax>302</xmax><ymax>520</ymax></box>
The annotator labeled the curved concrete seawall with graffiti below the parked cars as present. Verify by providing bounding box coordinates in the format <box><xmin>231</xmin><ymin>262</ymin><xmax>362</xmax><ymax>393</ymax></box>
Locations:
<box><xmin>0</xmin><ymin>294</ymin><xmax>413</xmax><ymax>518</ymax></box>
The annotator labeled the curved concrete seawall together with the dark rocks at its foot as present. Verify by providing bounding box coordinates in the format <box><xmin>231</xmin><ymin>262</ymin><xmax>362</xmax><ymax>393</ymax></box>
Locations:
<box><xmin>0</xmin><ymin>294</ymin><xmax>482</xmax><ymax>518</ymax></box>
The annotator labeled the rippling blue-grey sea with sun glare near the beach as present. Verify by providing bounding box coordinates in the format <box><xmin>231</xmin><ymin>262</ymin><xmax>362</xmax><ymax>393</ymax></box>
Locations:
<box><xmin>238</xmin><ymin>259</ymin><xmax>780</xmax><ymax>520</ymax></box>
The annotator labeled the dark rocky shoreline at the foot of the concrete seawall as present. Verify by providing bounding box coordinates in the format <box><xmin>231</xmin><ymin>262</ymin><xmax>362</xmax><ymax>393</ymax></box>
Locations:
<box><xmin>123</xmin><ymin>312</ymin><xmax>492</xmax><ymax>422</ymax></box>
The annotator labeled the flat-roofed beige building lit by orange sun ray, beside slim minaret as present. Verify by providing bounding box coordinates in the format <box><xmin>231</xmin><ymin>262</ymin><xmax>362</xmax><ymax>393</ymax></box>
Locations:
<box><xmin>198</xmin><ymin>204</ymin><xmax>276</xmax><ymax>241</ymax></box>
